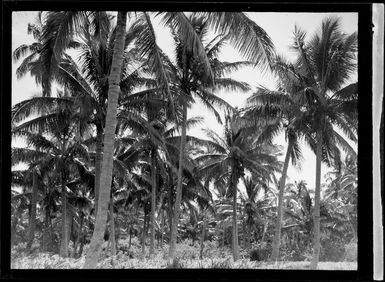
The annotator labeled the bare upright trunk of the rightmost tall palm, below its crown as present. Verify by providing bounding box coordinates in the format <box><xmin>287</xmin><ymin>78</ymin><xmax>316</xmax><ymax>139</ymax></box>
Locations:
<box><xmin>310</xmin><ymin>129</ymin><xmax>323</xmax><ymax>269</ymax></box>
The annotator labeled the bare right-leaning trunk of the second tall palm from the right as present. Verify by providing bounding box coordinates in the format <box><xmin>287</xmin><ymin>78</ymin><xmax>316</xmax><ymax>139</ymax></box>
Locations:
<box><xmin>271</xmin><ymin>140</ymin><xmax>293</xmax><ymax>262</ymax></box>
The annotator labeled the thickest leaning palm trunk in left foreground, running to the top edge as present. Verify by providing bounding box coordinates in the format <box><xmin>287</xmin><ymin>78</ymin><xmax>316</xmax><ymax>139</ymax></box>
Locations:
<box><xmin>83</xmin><ymin>11</ymin><xmax>127</xmax><ymax>268</ymax></box>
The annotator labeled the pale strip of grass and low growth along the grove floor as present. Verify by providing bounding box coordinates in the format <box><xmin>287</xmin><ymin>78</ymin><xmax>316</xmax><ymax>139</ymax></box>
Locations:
<box><xmin>11</xmin><ymin>240</ymin><xmax>357</xmax><ymax>270</ymax></box>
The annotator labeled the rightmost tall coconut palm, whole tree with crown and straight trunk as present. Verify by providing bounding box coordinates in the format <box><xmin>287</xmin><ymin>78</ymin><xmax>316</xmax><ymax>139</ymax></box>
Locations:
<box><xmin>282</xmin><ymin>18</ymin><xmax>358</xmax><ymax>269</ymax></box>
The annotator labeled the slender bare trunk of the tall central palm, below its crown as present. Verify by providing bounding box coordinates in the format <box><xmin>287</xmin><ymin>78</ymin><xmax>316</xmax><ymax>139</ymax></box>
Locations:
<box><xmin>169</xmin><ymin>103</ymin><xmax>187</xmax><ymax>262</ymax></box>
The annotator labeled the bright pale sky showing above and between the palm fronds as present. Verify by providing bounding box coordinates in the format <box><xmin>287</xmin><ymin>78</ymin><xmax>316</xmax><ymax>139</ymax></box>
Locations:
<box><xmin>12</xmin><ymin>12</ymin><xmax>358</xmax><ymax>190</ymax></box>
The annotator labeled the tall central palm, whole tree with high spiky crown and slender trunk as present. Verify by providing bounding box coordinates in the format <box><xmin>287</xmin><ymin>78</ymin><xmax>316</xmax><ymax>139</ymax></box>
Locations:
<box><xmin>160</xmin><ymin>15</ymin><xmax>260</xmax><ymax>260</ymax></box>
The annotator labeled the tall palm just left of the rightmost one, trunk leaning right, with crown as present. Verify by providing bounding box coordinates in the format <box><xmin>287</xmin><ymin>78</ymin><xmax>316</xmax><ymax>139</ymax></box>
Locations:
<box><xmin>245</xmin><ymin>56</ymin><xmax>307</xmax><ymax>261</ymax></box>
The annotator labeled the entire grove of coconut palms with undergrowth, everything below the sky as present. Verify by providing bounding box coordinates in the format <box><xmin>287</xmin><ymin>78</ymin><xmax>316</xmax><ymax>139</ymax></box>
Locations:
<box><xmin>10</xmin><ymin>11</ymin><xmax>358</xmax><ymax>269</ymax></box>
